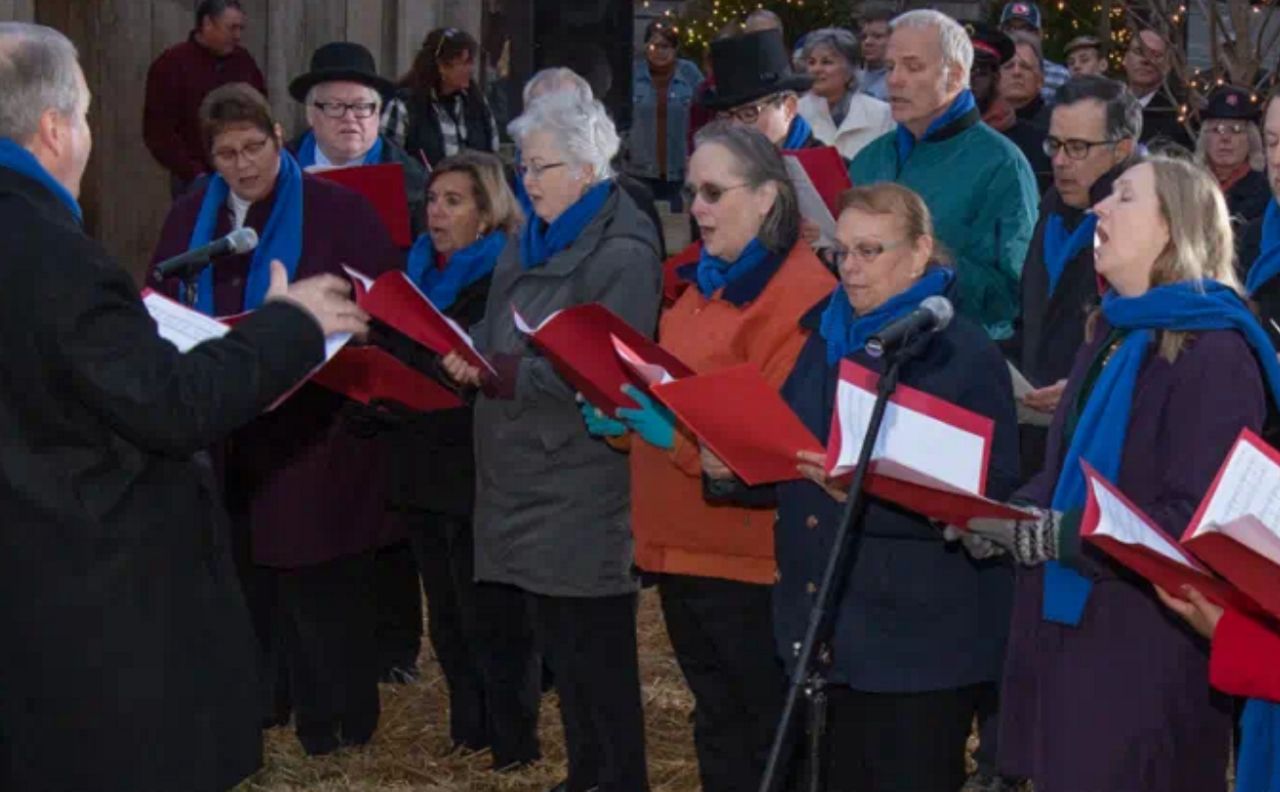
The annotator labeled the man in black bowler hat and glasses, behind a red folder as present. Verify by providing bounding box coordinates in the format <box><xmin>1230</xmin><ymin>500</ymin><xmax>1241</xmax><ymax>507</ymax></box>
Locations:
<box><xmin>288</xmin><ymin>41</ymin><xmax>426</xmax><ymax>238</ymax></box>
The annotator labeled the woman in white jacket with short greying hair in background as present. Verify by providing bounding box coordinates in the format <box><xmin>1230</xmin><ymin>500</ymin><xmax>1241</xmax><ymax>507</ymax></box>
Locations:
<box><xmin>800</xmin><ymin>28</ymin><xmax>893</xmax><ymax>160</ymax></box>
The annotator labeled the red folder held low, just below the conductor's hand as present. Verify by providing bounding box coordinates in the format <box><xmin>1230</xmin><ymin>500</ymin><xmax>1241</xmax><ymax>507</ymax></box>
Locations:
<box><xmin>311</xmin><ymin>347</ymin><xmax>462</xmax><ymax>412</ymax></box>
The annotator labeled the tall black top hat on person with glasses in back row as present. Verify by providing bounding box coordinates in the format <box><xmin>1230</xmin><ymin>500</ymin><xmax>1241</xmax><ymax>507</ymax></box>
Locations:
<box><xmin>703</xmin><ymin>29</ymin><xmax>813</xmax><ymax>110</ymax></box>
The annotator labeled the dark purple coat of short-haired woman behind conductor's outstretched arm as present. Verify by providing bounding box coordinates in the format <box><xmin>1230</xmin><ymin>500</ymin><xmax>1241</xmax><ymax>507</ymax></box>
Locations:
<box><xmin>154</xmin><ymin>175</ymin><xmax>401</xmax><ymax>568</ymax></box>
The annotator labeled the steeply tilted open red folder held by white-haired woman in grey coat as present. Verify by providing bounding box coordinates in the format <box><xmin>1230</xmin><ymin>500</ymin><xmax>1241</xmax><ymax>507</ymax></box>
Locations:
<box><xmin>343</xmin><ymin>267</ymin><xmax>497</xmax><ymax>374</ymax></box>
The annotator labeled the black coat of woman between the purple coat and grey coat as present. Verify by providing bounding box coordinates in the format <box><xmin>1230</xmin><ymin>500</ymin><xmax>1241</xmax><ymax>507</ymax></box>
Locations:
<box><xmin>376</xmin><ymin>276</ymin><xmax>491</xmax><ymax>521</ymax></box>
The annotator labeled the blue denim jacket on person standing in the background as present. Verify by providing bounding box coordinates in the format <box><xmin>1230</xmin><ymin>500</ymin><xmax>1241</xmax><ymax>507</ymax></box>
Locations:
<box><xmin>627</xmin><ymin>60</ymin><xmax>703</xmax><ymax>182</ymax></box>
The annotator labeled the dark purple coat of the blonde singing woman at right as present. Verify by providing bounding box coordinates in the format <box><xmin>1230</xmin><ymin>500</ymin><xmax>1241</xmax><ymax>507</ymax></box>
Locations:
<box><xmin>998</xmin><ymin>322</ymin><xmax>1267</xmax><ymax>792</ymax></box>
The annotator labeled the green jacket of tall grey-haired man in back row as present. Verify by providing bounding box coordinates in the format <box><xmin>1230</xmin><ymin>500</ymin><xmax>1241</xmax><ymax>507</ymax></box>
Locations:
<box><xmin>849</xmin><ymin>110</ymin><xmax>1039</xmax><ymax>340</ymax></box>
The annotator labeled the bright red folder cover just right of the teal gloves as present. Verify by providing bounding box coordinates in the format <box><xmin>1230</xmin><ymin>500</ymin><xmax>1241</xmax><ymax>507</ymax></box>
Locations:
<box><xmin>653</xmin><ymin>363</ymin><xmax>822</xmax><ymax>486</ymax></box>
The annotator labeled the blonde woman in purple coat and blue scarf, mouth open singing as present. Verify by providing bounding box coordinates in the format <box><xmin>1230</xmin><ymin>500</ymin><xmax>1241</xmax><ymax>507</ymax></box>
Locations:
<box><xmin>968</xmin><ymin>151</ymin><xmax>1280</xmax><ymax>792</ymax></box>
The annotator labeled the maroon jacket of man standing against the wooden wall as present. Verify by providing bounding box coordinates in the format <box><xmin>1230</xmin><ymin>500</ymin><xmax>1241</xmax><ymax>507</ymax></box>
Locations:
<box><xmin>142</xmin><ymin>31</ymin><xmax>266</xmax><ymax>182</ymax></box>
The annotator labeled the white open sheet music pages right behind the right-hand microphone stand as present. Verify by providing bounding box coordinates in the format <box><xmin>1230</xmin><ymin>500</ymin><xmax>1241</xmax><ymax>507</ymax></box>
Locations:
<box><xmin>836</xmin><ymin>381</ymin><xmax>987</xmax><ymax>495</ymax></box>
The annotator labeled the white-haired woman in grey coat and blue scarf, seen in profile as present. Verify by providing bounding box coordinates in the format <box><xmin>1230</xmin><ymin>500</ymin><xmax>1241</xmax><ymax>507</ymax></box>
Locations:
<box><xmin>444</xmin><ymin>93</ymin><xmax>662</xmax><ymax>792</ymax></box>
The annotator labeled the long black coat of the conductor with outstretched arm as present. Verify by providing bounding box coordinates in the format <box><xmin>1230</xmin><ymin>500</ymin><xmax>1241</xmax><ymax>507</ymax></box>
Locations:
<box><xmin>0</xmin><ymin>169</ymin><xmax>323</xmax><ymax>792</ymax></box>
